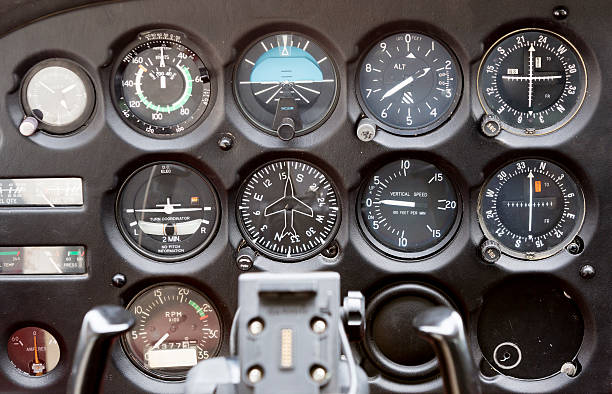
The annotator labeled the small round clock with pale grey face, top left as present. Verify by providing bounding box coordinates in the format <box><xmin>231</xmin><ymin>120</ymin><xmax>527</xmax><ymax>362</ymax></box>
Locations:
<box><xmin>21</xmin><ymin>59</ymin><xmax>96</xmax><ymax>135</ymax></box>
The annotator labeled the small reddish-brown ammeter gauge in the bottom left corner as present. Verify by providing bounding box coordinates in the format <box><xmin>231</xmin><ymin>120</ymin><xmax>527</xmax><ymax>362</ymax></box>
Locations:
<box><xmin>7</xmin><ymin>327</ymin><xmax>60</xmax><ymax>376</ymax></box>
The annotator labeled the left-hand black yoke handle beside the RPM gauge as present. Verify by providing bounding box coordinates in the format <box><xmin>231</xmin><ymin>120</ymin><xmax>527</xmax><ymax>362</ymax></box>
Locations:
<box><xmin>66</xmin><ymin>305</ymin><xmax>134</xmax><ymax>394</ymax></box>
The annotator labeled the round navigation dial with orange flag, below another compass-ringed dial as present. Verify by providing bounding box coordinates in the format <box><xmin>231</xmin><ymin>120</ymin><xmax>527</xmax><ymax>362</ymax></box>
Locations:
<box><xmin>478</xmin><ymin>159</ymin><xmax>584</xmax><ymax>260</ymax></box>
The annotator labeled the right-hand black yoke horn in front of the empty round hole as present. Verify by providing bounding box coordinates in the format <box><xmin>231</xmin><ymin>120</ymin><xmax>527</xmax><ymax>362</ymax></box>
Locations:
<box><xmin>412</xmin><ymin>306</ymin><xmax>481</xmax><ymax>394</ymax></box>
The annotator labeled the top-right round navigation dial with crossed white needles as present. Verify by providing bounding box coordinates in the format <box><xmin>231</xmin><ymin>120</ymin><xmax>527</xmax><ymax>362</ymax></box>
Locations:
<box><xmin>477</xmin><ymin>29</ymin><xmax>587</xmax><ymax>135</ymax></box>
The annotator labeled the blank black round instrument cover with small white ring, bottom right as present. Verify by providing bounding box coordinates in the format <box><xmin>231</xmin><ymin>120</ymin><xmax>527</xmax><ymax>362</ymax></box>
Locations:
<box><xmin>478</xmin><ymin>277</ymin><xmax>584</xmax><ymax>379</ymax></box>
